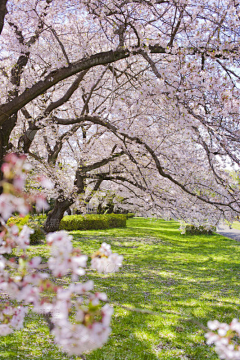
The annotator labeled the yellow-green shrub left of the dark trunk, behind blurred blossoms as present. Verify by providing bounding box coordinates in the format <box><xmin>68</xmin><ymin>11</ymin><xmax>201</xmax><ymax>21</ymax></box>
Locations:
<box><xmin>7</xmin><ymin>215</ymin><xmax>46</xmax><ymax>245</ymax></box>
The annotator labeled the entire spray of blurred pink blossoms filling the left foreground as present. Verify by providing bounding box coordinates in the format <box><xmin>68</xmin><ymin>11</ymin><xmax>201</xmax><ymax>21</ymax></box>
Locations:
<box><xmin>0</xmin><ymin>154</ymin><xmax>122</xmax><ymax>355</ymax></box>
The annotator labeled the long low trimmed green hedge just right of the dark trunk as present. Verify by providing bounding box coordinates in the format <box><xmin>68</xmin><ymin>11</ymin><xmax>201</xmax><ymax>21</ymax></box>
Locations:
<box><xmin>59</xmin><ymin>214</ymin><xmax>126</xmax><ymax>231</ymax></box>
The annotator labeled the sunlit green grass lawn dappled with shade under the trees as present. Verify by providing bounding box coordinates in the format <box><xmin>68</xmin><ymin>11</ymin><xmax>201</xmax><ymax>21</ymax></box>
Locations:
<box><xmin>0</xmin><ymin>218</ymin><xmax>240</xmax><ymax>360</ymax></box>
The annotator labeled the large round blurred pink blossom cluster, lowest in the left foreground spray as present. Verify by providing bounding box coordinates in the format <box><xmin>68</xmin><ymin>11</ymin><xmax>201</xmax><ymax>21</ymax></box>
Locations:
<box><xmin>50</xmin><ymin>281</ymin><xmax>113</xmax><ymax>355</ymax></box>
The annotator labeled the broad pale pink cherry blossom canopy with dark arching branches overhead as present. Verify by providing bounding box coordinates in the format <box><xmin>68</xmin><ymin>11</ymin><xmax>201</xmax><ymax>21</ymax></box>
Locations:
<box><xmin>0</xmin><ymin>0</ymin><xmax>239</xmax><ymax>228</ymax></box>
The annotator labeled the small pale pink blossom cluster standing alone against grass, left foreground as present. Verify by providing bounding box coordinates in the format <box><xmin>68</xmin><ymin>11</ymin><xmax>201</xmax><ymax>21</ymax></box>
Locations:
<box><xmin>91</xmin><ymin>242</ymin><xmax>123</xmax><ymax>274</ymax></box>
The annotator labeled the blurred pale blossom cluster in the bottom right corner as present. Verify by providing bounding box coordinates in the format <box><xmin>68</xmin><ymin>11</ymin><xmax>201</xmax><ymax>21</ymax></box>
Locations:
<box><xmin>205</xmin><ymin>319</ymin><xmax>240</xmax><ymax>360</ymax></box>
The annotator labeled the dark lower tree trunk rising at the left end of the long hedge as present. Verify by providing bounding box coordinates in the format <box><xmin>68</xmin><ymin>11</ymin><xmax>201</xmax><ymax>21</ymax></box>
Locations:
<box><xmin>44</xmin><ymin>198</ymin><xmax>74</xmax><ymax>233</ymax></box>
